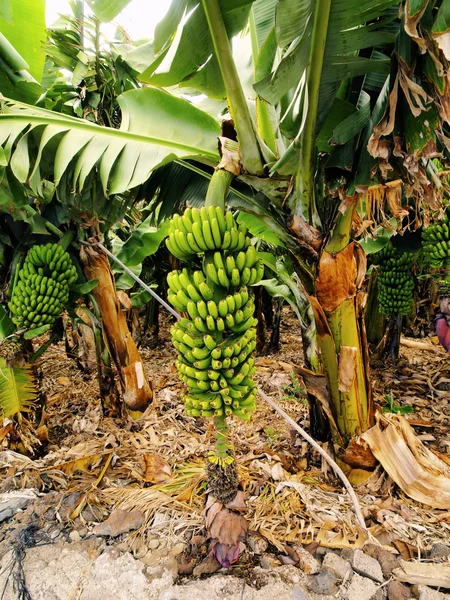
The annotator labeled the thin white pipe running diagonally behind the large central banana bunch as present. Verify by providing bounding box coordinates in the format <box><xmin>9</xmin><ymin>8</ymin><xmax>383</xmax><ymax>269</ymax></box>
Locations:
<box><xmin>89</xmin><ymin>242</ymin><xmax>367</xmax><ymax>531</ymax></box>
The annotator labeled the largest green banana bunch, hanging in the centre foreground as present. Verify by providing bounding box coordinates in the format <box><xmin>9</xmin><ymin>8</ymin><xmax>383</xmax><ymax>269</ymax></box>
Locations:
<box><xmin>166</xmin><ymin>207</ymin><xmax>264</xmax><ymax>420</ymax></box>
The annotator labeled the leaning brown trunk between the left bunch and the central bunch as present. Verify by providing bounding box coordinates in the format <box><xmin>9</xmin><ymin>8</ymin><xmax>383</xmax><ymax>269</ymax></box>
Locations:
<box><xmin>80</xmin><ymin>246</ymin><xmax>153</xmax><ymax>412</ymax></box>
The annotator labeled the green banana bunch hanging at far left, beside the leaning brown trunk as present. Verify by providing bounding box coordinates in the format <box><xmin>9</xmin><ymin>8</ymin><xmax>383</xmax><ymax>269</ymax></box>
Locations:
<box><xmin>8</xmin><ymin>244</ymin><xmax>78</xmax><ymax>329</ymax></box>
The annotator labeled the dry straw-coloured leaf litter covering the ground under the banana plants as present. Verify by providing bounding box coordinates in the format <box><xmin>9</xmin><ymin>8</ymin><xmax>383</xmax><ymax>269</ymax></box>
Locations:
<box><xmin>0</xmin><ymin>314</ymin><xmax>450</xmax><ymax>550</ymax></box>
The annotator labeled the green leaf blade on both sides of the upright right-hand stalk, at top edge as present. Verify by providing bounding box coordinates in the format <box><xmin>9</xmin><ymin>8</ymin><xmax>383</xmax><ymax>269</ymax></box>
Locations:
<box><xmin>255</xmin><ymin>0</ymin><xmax>400</xmax><ymax>120</ymax></box>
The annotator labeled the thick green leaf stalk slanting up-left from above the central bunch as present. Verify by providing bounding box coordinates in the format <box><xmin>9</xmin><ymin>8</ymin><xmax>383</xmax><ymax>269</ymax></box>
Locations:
<box><xmin>202</xmin><ymin>0</ymin><xmax>264</xmax><ymax>175</ymax></box>
